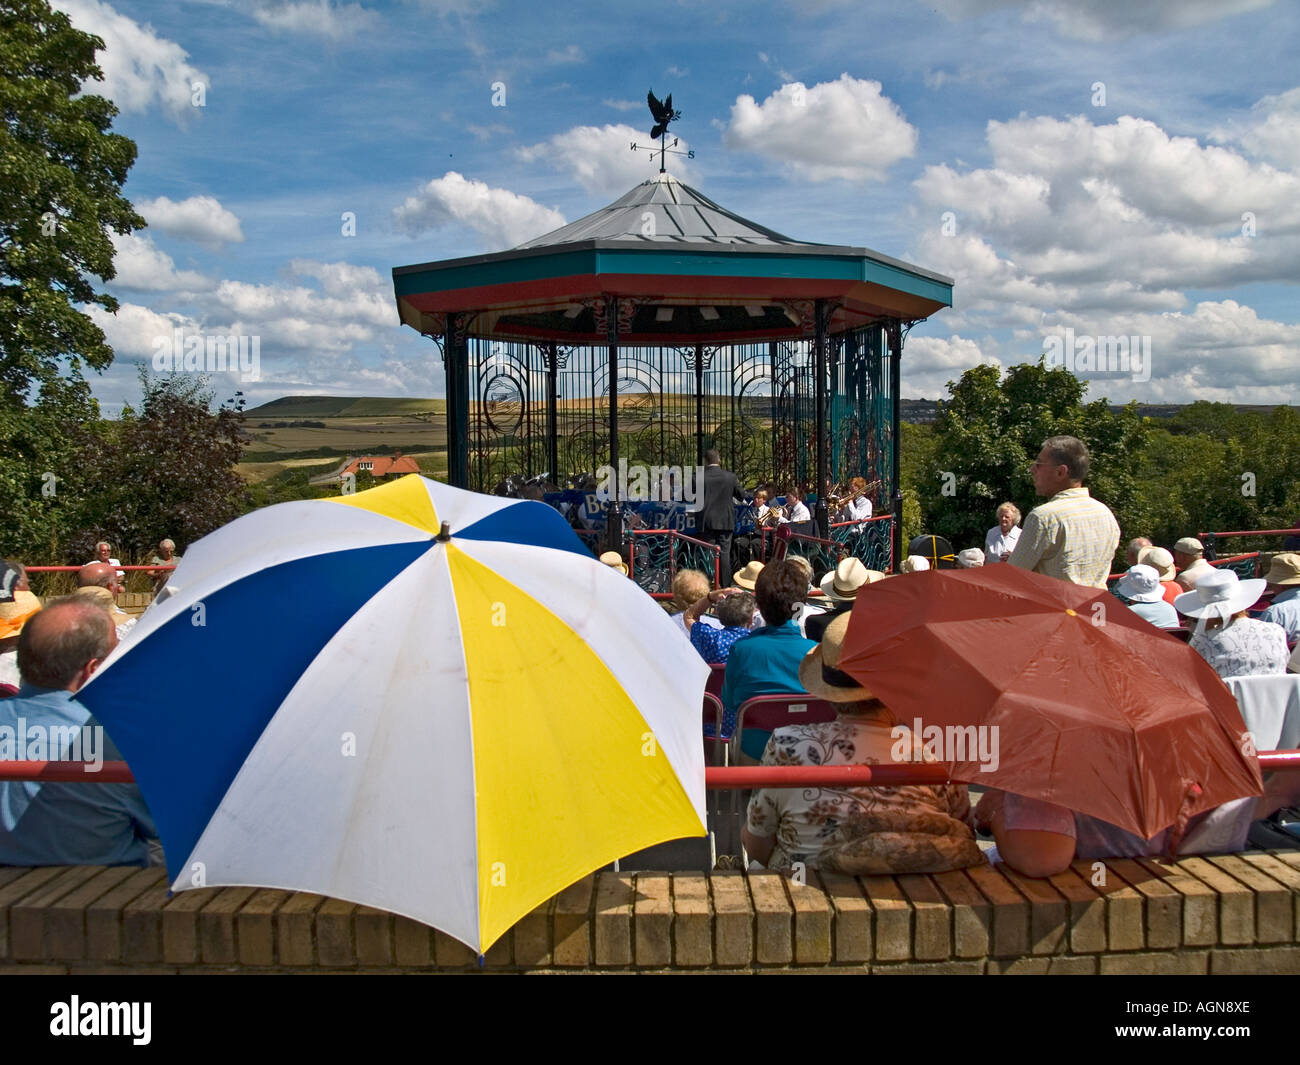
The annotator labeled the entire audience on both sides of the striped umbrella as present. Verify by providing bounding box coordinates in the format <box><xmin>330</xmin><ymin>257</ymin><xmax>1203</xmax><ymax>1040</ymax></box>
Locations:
<box><xmin>0</xmin><ymin>437</ymin><xmax>1300</xmax><ymax>876</ymax></box>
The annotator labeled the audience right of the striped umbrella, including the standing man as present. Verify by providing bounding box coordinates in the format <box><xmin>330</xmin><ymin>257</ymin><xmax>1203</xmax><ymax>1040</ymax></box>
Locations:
<box><xmin>660</xmin><ymin>438</ymin><xmax>1300</xmax><ymax>876</ymax></box>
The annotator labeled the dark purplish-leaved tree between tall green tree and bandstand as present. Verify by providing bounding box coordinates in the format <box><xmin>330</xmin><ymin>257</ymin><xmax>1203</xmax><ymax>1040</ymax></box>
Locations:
<box><xmin>70</xmin><ymin>364</ymin><xmax>248</xmax><ymax>560</ymax></box>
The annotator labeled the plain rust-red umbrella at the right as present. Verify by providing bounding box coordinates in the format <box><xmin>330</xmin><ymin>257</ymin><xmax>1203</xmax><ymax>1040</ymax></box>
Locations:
<box><xmin>840</xmin><ymin>563</ymin><xmax>1262</xmax><ymax>839</ymax></box>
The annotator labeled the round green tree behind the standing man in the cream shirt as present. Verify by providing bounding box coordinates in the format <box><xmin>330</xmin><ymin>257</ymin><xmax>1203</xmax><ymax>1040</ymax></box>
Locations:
<box><xmin>904</xmin><ymin>359</ymin><xmax>1147</xmax><ymax>561</ymax></box>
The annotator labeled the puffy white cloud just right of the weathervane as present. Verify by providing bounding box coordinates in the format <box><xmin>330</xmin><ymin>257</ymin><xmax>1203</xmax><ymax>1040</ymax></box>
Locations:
<box><xmin>723</xmin><ymin>74</ymin><xmax>917</xmax><ymax>181</ymax></box>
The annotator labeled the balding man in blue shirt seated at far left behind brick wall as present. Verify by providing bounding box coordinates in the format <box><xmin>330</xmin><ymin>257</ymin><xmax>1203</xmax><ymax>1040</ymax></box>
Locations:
<box><xmin>0</xmin><ymin>598</ymin><xmax>161</xmax><ymax>866</ymax></box>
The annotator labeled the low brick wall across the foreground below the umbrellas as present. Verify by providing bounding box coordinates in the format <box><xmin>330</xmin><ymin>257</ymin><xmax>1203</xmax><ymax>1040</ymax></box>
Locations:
<box><xmin>0</xmin><ymin>850</ymin><xmax>1300</xmax><ymax>974</ymax></box>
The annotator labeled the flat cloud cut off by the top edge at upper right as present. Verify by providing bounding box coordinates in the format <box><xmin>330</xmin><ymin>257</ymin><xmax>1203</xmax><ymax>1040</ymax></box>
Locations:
<box><xmin>927</xmin><ymin>0</ymin><xmax>1273</xmax><ymax>40</ymax></box>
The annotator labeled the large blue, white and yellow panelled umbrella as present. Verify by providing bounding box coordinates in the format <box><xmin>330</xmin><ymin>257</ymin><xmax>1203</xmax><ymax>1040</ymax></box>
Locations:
<box><xmin>79</xmin><ymin>476</ymin><xmax>709</xmax><ymax>952</ymax></box>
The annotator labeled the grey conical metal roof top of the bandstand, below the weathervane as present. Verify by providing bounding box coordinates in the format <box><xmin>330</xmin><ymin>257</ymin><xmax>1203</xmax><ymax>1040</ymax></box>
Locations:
<box><xmin>515</xmin><ymin>174</ymin><xmax>809</xmax><ymax>251</ymax></box>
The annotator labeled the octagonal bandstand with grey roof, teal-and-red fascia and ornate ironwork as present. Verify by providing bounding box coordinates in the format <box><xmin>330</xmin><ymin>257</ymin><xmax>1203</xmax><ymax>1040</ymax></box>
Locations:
<box><xmin>393</xmin><ymin>173</ymin><xmax>953</xmax><ymax>579</ymax></box>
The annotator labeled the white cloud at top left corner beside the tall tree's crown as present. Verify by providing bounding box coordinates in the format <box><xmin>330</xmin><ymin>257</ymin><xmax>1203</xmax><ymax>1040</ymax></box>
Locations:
<box><xmin>57</xmin><ymin>0</ymin><xmax>209</xmax><ymax>124</ymax></box>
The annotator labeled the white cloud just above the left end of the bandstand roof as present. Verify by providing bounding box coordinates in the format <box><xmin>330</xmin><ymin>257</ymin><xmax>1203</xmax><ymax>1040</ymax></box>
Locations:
<box><xmin>393</xmin><ymin>170</ymin><xmax>564</xmax><ymax>251</ymax></box>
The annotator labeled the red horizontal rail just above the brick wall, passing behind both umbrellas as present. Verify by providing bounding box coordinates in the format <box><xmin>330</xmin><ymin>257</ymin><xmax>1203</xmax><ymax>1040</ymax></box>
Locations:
<box><xmin>10</xmin><ymin>750</ymin><xmax>1300</xmax><ymax>791</ymax></box>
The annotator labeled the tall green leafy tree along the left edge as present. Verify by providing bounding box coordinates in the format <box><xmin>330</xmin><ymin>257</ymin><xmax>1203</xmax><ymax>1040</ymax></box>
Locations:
<box><xmin>0</xmin><ymin>0</ymin><xmax>144</xmax><ymax>557</ymax></box>
